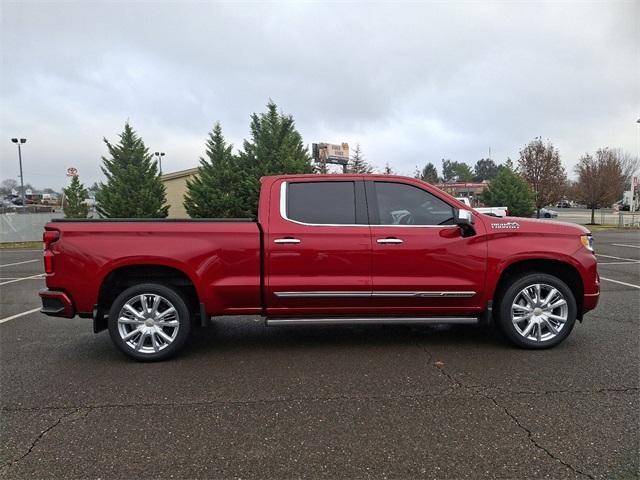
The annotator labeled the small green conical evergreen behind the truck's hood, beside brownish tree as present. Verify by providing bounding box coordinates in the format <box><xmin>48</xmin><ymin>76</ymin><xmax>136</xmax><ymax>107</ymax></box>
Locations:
<box><xmin>482</xmin><ymin>168</ymin><xmax>535</xmax><ymax>217</ymax></box>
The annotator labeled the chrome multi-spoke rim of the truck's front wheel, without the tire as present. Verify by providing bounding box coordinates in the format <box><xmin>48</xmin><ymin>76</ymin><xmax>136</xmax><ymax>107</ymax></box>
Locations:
<box><xmin>511</xmin><ymin>283</ymin><xmax>569</xmax><ymax>342</ymax></box>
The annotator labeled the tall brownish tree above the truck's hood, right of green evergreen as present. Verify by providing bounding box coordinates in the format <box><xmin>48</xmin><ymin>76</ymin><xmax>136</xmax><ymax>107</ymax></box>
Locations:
<box><xmin>518</xmin><ymin>137</ymin><xmax>567</xmax><ymax>217</ymax></box>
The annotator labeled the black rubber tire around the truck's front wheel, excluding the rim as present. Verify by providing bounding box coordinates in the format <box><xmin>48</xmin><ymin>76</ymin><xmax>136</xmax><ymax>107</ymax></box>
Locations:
<box><xmin>496</xmin><ymin>273</ymin><xmax>577</xmax><ymax>349</ymax></box>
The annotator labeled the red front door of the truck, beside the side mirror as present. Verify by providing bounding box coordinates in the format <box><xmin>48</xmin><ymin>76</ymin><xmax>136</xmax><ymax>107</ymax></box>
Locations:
<box><xmin>366</xmin><ymin>181</ymin><xmax>487</xmax><ymax>315</ymax></box>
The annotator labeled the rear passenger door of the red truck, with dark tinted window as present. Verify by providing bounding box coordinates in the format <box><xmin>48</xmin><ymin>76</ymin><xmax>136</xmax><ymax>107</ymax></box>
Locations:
<box><xmin>265</xmin><ymin>177</ymin><xmax>371</xmax><ymax>316</ymax></box>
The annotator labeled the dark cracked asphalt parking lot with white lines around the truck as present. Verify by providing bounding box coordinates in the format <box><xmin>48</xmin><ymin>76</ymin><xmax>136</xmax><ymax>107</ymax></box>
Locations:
<box><xmin>0</xmin><ymin>231</ymin><xmax>640</xmax><ymax>478</ymax></box>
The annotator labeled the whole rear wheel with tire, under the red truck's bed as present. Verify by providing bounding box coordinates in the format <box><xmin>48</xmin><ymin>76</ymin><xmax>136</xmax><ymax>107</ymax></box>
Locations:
<box><xmin>109</xmin><ymin>283</ymin><xmax>191</xmax><ymax>361</ymax></box>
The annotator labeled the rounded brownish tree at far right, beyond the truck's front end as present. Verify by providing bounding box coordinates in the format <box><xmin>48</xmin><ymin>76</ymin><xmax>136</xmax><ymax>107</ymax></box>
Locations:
<box><xmin>575</xmin><ymin>148</ymin><xmax>628</xmax><ymax>224</ymax></box>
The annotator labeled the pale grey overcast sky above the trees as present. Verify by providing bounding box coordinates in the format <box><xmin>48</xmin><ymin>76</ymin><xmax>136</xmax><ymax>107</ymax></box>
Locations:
<box><xmin>0</xmin><ymin>0</ymin><xmax>640</xmax><ymax>188</ymax></box>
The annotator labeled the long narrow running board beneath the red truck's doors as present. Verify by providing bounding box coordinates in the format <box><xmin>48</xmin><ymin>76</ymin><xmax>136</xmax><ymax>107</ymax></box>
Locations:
<box><xmin>265</xmin><ymin>317</ymin><xmax>478</xmax><ymax>326</ymax></box>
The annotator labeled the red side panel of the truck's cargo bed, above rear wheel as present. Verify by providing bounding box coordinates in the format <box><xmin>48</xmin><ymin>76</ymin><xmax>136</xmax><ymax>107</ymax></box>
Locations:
<box><xmin>45</xmin><ymin>218</ymin><xmax>262</xmax><ymax>316</ymax></box>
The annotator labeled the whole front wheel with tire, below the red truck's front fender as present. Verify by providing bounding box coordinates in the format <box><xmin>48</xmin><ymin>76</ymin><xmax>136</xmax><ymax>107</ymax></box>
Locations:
<box><xmin>497</xmin><ymin>273</ymin><xmax>577</xmax><ymax>349</ymax></box>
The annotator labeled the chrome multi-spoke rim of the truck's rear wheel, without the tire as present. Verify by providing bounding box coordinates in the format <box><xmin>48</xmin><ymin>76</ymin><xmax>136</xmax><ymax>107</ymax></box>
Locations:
<box><xmin>118</xmin><ymin>293</ymin><xmax>180</xmax><ymax>353</ymax></box>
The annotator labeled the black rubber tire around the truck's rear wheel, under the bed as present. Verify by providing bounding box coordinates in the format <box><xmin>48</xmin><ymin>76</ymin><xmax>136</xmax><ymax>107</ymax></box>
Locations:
<box><xmin>108</xmin><ymin>283</ymin><xmax>192</xmax><ymax>362</ymax></box>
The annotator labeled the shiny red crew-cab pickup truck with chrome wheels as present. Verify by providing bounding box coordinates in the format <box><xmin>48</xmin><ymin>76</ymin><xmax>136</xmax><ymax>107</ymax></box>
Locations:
<box><xmin>40</xmin><ymin>175</ymin><xmax>600</xmax><ymax>360</ymax></box>
